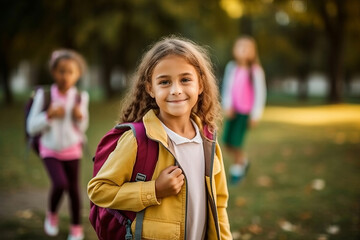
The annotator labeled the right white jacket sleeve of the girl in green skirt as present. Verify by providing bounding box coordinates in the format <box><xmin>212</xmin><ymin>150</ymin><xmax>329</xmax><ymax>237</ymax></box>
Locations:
<box><xmin>250</xmin><ymin>66</ymin><xmax>266</xmax><ymax>120</ymax></box>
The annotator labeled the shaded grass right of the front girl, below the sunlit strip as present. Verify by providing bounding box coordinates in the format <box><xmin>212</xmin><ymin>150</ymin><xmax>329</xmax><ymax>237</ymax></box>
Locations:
<box><xmin>225</xmin><ymin>122</ymin><xmax>360</xmax><ymax>240</ymax></box>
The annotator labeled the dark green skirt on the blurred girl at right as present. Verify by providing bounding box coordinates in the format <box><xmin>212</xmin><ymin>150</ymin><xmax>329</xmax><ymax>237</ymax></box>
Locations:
<box><xmin>223</xmin><ymin>113</ymin><xmax>249</xmax><ymax>148</ymax></box>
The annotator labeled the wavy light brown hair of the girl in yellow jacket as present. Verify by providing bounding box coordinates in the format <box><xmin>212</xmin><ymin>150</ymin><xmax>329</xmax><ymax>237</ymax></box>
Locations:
<box><xmin>120</xmin><ymin>36</ymin><xmax>221</xmax><ymax>131</ymax></box>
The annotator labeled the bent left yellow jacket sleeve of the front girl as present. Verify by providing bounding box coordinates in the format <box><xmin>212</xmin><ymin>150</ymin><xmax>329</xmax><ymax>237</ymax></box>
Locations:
<box><xmin>88</xmin><ymin>131</ymin><xmax>160</xmax><ymax>212</ymax></box>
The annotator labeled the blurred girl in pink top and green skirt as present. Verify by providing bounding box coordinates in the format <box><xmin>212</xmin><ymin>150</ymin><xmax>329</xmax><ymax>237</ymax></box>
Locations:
<box><xmin>222</xmin><ymin>36</ymin><xmax>266</xmax><ymax>184</ymax></box>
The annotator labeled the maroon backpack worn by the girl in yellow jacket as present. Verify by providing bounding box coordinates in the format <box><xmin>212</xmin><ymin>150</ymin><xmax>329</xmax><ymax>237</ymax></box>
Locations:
<box><xmin>89</xmin><ymin>122</ymin><xmax>159</xmax><ymax>240</ymax></box>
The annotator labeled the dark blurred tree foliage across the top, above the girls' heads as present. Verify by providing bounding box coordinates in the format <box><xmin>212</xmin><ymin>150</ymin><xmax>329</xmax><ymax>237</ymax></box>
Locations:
<box><xmin>0</xmin><ymin>0</ymin><xmax>360</xmax><ymax>104</ymax></box>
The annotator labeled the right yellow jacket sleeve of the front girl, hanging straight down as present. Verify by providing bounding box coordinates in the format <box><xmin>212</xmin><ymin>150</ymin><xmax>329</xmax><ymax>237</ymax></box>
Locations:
<box><xmin>215</xmin><ymin>144</ymin><xmax>232</xmax><ymax>240</ymax></box>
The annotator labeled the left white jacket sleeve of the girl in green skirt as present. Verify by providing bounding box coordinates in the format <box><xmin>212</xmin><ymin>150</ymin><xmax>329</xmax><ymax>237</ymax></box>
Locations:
<box><xmin>221</xmin><ymin>61</ymin><xmax>235</xmax><ymax>110</ymax></box>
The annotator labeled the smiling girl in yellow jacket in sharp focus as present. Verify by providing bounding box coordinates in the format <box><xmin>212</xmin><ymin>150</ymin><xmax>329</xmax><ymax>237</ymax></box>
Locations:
<box><xmin>88</xmin><ymin>37</ymin><xmax>231</xmax><ymax>240</ymax></box>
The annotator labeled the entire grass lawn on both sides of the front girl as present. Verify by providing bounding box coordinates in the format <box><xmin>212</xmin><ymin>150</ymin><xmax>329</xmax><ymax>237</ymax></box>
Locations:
<box><xmin>0</xmin><ymin>98</ymin><xmax>360</xmax><ymax>240</ymax></box>
